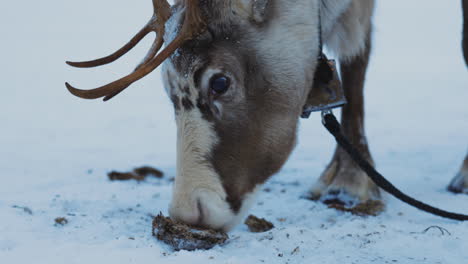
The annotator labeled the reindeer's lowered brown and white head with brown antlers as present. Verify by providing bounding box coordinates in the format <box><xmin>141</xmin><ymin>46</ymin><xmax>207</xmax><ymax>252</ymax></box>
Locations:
<box><xmin>67</xmin><ymin>0</ymin><xmax>319</xmax><ymax>230</ymax></box>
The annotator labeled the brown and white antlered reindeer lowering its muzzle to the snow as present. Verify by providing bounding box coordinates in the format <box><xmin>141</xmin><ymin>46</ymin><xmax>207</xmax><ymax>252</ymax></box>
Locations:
<box><xmin>67</xmin><ymin>0</ymin><xmax>468</xmax><ymax>231</ymax></box>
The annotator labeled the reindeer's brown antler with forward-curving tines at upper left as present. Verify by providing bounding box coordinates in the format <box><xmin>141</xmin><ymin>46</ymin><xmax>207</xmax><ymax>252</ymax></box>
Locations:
<box><xmin>66</xmin><ymin>0</ymin><xmax>205</xmax><ymax>101</ymax></box>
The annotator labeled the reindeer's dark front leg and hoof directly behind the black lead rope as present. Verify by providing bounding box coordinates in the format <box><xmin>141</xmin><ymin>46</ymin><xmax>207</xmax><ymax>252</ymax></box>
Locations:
<box><xmin>311</xmin><ymin>29</ymin><xmax>383</xmax><ymax>215</ymax></box>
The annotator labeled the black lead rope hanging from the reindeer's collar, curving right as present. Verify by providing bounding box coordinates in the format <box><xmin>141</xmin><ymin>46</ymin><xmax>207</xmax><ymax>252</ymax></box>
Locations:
<box><xmin>322</xmin><ymin>111</ymin><xmax>468</xmax><ymax>221</ymax></box>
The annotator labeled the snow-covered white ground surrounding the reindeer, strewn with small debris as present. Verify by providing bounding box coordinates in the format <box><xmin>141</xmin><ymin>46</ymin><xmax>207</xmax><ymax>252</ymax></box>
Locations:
<box><xmin>0</xmin><ymin>0</ymin><xmax>468</xmax><ymax>264</ymax></box>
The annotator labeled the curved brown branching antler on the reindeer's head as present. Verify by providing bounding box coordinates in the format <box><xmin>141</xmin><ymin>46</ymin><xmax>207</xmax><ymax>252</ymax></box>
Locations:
<box><xmin>65</xmin><ymin>0</ymin><xmax>205</xmax><ymax>101</ymax></box>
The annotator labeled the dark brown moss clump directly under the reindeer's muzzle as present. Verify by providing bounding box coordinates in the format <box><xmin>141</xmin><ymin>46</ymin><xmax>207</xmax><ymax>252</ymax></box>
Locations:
<box><xmin>153</xmin><ymin>214</ymin><xmax>229</xmax><ymax>251</ymax></box>
